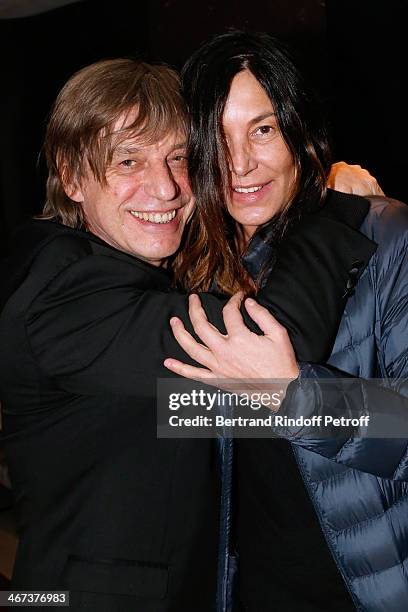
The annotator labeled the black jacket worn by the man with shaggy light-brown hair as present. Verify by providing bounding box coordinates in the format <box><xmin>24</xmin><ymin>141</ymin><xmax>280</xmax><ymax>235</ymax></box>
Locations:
<box><xmin>0</xmin><ymin>197</ymin><xmax>371</xmax><ymax>612</ymax></box>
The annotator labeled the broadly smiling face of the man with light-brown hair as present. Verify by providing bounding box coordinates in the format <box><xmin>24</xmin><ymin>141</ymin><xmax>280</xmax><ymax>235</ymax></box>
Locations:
<box><xmin>69</xmin><ymin>119</ymin><xmax>194</xmax><ymax>266</ymax></box>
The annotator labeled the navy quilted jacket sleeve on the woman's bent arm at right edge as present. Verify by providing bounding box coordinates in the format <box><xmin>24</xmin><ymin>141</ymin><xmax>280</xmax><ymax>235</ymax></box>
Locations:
<box><xmin>280</xmin><ymin>198</ymin><xmax>408</xmax><ymax>481</ymax></box>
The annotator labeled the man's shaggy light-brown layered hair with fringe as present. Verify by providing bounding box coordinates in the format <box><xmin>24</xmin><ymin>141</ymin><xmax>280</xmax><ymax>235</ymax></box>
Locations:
<box><xmin>41</xmin><ymin>59</ymin><xmax>187</xmax><ymax>229</ymax></box>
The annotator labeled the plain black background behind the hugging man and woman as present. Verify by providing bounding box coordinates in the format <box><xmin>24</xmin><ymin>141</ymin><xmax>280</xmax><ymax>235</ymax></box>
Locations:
<box><xmin>0</xmin><ymin>0</ymin><xmax>408</xmax><ymax>252</ymax></box>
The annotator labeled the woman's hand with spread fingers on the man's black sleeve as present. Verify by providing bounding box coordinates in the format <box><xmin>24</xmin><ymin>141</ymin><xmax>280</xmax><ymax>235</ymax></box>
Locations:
<box><xmin>164</xmin><ymin>293</ymin><xmax>299</xmax><ymax>384</ymax></box>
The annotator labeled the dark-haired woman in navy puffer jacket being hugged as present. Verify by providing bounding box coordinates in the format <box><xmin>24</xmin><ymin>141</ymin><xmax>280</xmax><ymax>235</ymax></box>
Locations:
<box><xmin>166</xmin><ymin>32</ymin><xmax>408</xmax><ymax>612</ymax></box>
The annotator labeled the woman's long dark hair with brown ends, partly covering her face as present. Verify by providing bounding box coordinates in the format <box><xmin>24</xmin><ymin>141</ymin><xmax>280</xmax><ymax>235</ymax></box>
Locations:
<box><xmin>174</xmin><ymin>30</ymin><xmax>331</xmax><ymax>294</ymax></box>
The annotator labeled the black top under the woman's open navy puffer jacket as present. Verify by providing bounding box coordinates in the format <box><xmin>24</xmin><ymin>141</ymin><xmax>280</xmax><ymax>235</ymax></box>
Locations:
<box><xmin>236</xmin><ymin>439</ymin><xmax>355</xmax><ymax>612</ymax></box>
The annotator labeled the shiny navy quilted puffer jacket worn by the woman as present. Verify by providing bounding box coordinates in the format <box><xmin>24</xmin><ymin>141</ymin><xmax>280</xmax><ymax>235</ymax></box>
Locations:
<box><xmin>220</xmin><ymin>197</ymin><xmax>408</xmax><ymax>612</ymax></box>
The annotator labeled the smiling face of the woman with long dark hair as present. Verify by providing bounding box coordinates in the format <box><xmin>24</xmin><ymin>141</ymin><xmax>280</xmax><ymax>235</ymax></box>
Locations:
<box><xmin>222</xmin><ymin>70</ymin><xmax>296</xmax><ymax>239</ymax></box>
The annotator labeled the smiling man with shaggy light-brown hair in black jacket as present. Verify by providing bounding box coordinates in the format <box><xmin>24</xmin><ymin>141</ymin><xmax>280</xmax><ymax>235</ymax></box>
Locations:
<box><xmin>0</xmin><ymin>59</ymin><xmax>221</xmax><ymax>612</ymax></box>
